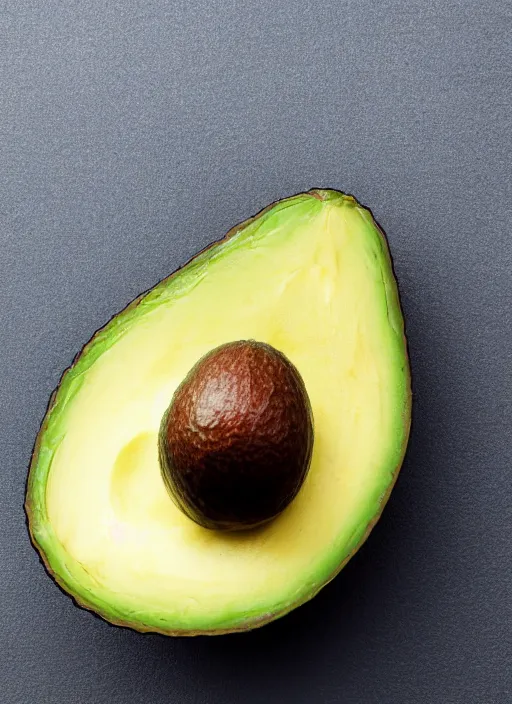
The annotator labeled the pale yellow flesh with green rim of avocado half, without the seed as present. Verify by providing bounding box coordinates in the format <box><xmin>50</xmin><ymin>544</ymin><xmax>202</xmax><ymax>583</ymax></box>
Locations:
<box><xmin>26</xmin><ymin>191</ymin><xmax>410</xmax><ymax>635</ymax></box>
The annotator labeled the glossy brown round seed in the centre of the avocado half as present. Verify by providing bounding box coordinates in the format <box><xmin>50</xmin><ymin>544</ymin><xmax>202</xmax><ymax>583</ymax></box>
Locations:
<box><xmin>159</xmin><ymin>340</ymin><xmax>313</xmax><ymax>530</ymax></box>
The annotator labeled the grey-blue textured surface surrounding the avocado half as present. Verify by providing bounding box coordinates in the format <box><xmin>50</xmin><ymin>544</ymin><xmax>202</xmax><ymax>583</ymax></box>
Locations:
<box><xmin>0</xmin><ymin>0</ymin><xmax>512</xmax><ymax>704</ymax></box>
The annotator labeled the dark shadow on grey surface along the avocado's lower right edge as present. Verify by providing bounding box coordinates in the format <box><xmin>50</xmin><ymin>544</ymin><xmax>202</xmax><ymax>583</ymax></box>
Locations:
<box><xmin>136</xmin><ymin>276</ymin><xmax>444</xmax><ymax>673</ymax></box>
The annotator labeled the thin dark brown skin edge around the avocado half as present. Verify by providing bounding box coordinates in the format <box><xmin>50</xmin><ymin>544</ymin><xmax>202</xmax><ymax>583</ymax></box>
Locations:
<box><xmin>24</xmin><ymin>188</ymin><xmax>413</xmax><ymax>637</ymax></box>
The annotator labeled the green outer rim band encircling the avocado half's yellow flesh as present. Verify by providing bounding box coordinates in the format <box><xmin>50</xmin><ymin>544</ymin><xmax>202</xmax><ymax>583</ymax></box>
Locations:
<box><xmin>25</xmin><ymin>189</ymin><xmax>412</xmax><ymax>636</ymax></box>
